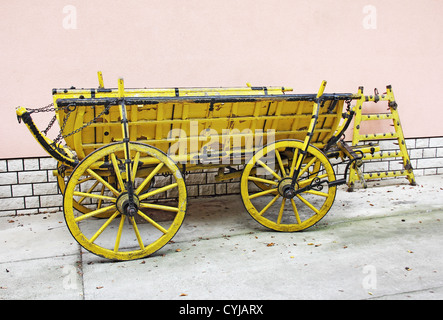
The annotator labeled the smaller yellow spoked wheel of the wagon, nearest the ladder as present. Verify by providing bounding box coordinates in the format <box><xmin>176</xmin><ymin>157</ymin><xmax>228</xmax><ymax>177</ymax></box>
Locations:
<box><xmin>241</xmin><ymin>140</ymin><xmax>336</xmax><ymax>231</ymax></box>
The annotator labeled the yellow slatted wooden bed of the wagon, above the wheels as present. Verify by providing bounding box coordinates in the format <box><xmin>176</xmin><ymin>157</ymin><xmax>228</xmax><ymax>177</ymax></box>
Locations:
<box><xmin>53</xmin><ymin>87</ymin><xmax>353</xmax><ymax>162</ymax></box>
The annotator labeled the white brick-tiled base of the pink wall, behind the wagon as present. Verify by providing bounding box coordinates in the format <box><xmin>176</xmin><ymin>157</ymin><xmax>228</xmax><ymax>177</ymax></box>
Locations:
<box><xmin>0</xmin><ymin>137</ymin><xmax>443</xmax><ymax>216</ymax></box>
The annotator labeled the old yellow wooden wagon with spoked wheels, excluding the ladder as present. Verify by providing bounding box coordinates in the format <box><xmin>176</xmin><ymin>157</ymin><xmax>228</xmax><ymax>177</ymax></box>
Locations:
<box><xmin>17</xmin><ymin>72</ymin><xmax>412</xmax><ymax>260</ymax></box>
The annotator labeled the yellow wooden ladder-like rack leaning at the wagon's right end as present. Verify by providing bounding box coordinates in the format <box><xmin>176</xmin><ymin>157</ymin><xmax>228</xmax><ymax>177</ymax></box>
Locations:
<box><xmin>348</xmin><ymin>86</ymin><xmax>416</xmax><ymax>191</ymax></box>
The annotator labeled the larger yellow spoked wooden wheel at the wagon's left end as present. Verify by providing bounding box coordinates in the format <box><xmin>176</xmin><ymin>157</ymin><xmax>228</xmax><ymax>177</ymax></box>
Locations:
<box><xmin>64</xmin><ymin>143</ymin><xmax>186</xmax><ymax>260</ymax></box>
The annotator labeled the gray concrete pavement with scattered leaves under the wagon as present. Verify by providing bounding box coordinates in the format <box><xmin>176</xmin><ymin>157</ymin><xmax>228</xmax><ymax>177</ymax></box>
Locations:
<box><xmin>0</xmin><ymin>175</ymin><xmax>443</xmax><ymax>300</ymax></box>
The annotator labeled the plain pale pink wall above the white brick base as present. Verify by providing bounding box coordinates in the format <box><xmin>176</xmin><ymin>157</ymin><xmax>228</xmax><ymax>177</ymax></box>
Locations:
<box><xmin>0</xmin><ymin>0</ymin><xmax>443</xmax><ymax>158</ymax></box>
